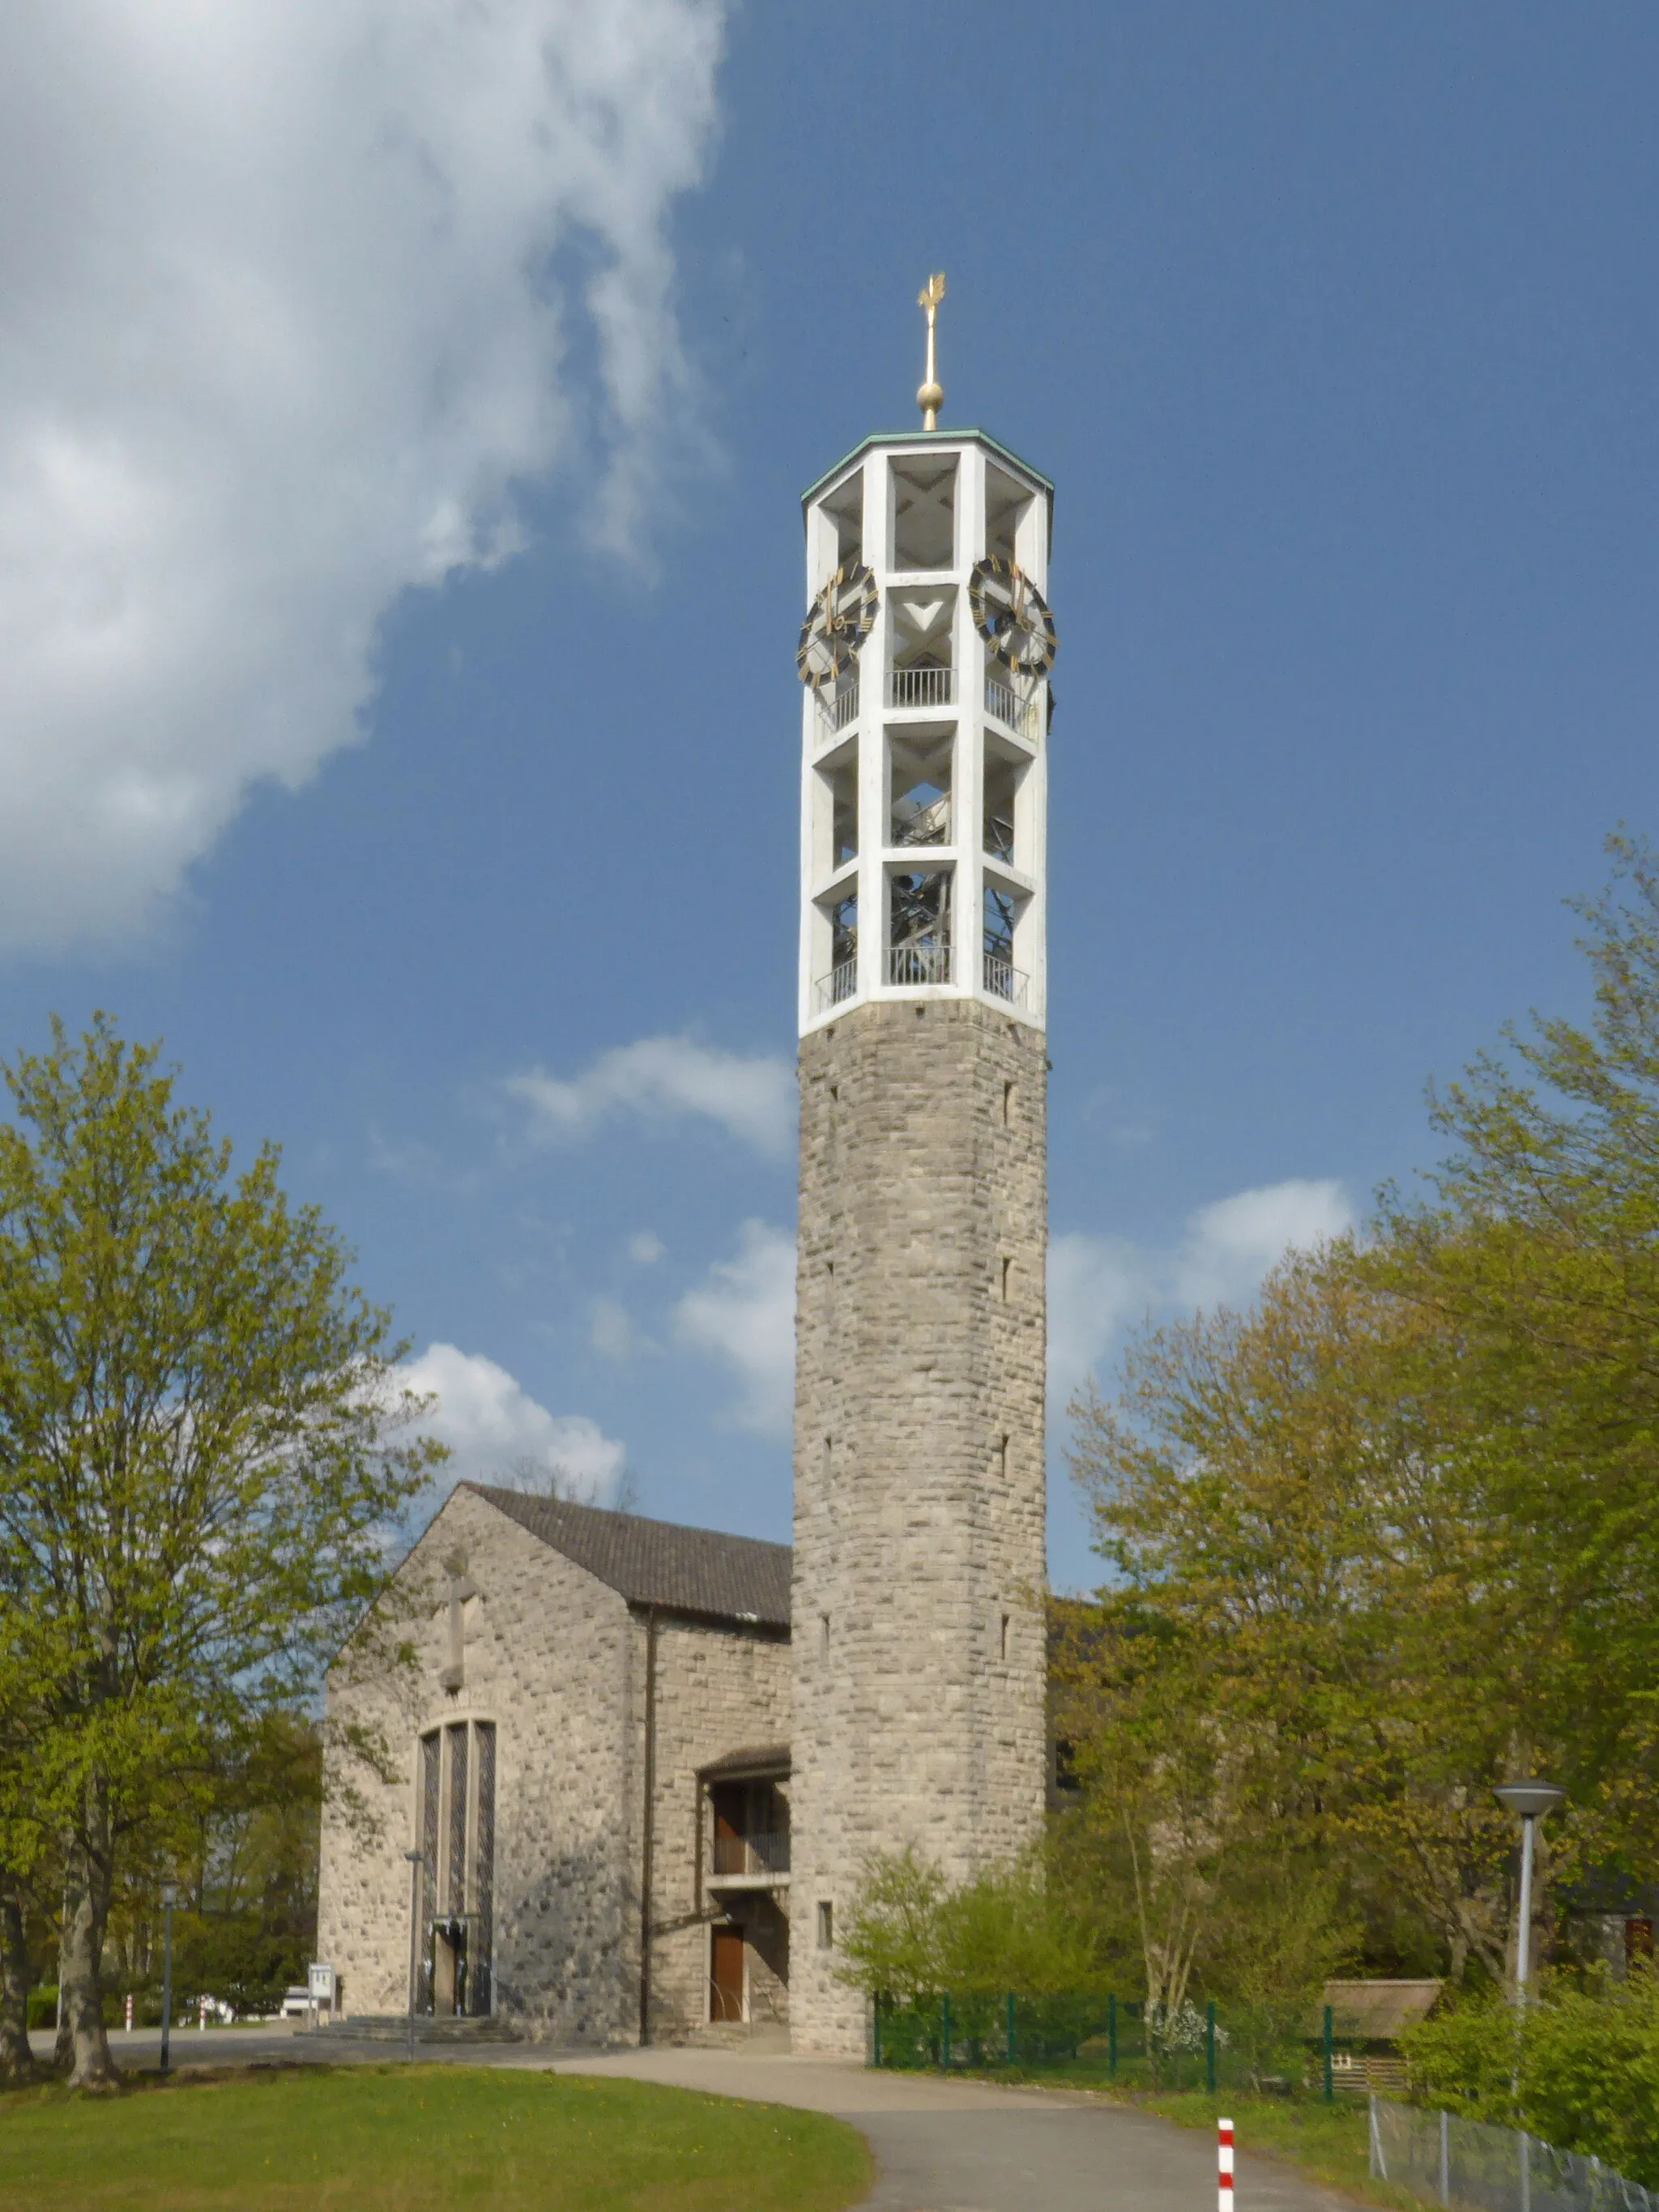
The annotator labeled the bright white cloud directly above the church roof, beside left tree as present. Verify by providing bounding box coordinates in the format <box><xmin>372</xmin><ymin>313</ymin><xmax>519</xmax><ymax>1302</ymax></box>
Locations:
<box><xmin>400</xmin><ymin>1345</ymin><xmax>629</xmax><ymax>1504</ymax></box>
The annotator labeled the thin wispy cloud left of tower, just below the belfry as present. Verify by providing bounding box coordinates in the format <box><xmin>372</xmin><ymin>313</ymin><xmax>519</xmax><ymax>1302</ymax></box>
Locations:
<box><xmin>506</xmin><ymin>1038</ymin><xmax>794</xmax><ymax>1157</ymax></box>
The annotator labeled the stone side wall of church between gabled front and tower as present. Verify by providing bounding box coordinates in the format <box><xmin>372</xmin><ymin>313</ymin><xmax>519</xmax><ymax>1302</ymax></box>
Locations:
<box><xmin>630</xmin><ymin>1610</ymin><xmax>790</xmax><ymax>2042</ymax></box>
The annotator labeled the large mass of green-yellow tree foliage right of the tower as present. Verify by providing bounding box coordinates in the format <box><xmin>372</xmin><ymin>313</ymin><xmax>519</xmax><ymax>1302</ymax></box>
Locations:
<box><xmin>1057</xmin><ymin>841</ymin><xmax>1659</xmax><ymax>2004</ymax></box>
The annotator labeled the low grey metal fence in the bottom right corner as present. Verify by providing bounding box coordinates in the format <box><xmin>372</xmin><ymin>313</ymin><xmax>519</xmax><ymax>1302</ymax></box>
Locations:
<box><xmin>1371</xmin><ymin>2097</ymin><xmax>1659</xmax><ymax>2212</ymax></box>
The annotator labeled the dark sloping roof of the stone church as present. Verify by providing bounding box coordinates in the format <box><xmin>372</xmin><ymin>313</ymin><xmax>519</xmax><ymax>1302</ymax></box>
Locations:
<box><xmin>467</xmin><ymin>1482</ymin><xmax>790</xmax><ymax>1628</ymax></box>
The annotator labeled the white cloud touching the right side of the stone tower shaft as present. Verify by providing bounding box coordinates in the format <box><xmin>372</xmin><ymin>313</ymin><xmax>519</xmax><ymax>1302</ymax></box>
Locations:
<box><xmin>1048</xmin><ymin>1177</ymin><xmax>1354</xmax><ymax>1404</ymax></box>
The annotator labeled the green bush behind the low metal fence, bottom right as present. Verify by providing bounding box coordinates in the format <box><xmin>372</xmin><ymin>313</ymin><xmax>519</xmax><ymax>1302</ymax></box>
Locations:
<box><xmin>1401</xmin><ymin>1971</ymin><xmax>1659</xmax><ymax>2188</ymax></box>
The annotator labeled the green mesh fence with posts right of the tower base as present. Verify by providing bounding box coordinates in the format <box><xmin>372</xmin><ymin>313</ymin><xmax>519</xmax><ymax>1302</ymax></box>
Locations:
<box><xmin>872</xmin><ymin>1991</ymin><xmax>1367</xmax><ymax>2099</ymax></box>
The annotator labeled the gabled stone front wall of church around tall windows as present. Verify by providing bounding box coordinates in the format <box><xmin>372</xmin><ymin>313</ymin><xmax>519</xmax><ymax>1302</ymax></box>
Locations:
<box><xmin>318</xmin><ymin>1489</ymin><xmax>639</xmax><ymax>2044</ymax></box>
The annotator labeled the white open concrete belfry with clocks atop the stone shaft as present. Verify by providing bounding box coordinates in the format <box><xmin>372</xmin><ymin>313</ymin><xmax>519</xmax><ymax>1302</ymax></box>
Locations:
<box><xmin>801</xmin><ymin>432</ymin><xmax>1053</xmax><ymax>1035</ymax></box>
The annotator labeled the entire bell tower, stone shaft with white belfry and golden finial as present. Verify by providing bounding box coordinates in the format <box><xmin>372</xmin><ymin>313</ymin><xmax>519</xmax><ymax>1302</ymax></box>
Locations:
<box><xmin>790</xmin><ymin>276</ymin><xmax>1056</xmax><ymax>2052</ymax></box>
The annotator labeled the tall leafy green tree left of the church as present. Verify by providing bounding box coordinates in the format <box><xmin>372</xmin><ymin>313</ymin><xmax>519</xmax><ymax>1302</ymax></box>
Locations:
<box><xmin>0</xmin><ymin>1017</ymin><xmax>440</xmax><ymax>2086</ymax></box>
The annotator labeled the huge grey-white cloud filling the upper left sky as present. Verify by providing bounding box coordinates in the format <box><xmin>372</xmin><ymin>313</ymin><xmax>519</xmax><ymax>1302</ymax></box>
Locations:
<box><xmin>0</xmin><ymin>0</ymin><xmax>723</xmax><ymax>947</ymax></box>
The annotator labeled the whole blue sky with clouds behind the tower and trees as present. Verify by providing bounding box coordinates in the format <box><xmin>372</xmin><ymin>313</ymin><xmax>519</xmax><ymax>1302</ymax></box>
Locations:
<box><xmin>0</xmin><ymin>0</ymin><xmax>1659</xmax><ymax>1583</ymax></box>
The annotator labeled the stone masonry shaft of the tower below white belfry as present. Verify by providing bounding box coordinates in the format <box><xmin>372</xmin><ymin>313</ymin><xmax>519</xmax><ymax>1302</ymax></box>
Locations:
<box><xmin>790</xmin><ymin>998</ymin><xmax>1047</xmax><ymax>2052</ymax></box>
